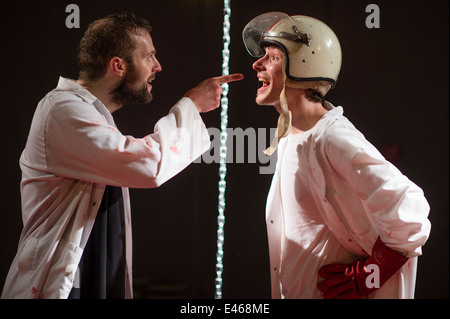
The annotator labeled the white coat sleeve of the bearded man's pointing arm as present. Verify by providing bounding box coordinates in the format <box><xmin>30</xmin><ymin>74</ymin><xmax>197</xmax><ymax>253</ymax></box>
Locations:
<box><xmin>45</xmin><ymin>96</ymin><xmax>210</xmax><ymax>188</ymax></box>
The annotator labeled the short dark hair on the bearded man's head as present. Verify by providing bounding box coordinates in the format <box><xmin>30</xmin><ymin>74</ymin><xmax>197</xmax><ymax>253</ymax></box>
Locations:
<box><xmin>77</xmin><ymin>12</ymin><xmax>151</xmax><ymax>81</ymax></box>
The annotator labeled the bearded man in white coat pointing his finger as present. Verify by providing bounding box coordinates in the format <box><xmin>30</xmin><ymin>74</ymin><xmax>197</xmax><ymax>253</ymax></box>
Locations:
<box><xmin>2</xmin><ymin>13</ymin><xmax>242</xmax><ymax>299</ymax></box>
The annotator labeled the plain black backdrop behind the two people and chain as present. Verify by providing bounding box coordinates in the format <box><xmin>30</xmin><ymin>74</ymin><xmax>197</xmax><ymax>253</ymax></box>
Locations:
<box><xmin>0</xmin><ymin>0</ymin><xmax>449</xmax><ymax>298</ymax></box>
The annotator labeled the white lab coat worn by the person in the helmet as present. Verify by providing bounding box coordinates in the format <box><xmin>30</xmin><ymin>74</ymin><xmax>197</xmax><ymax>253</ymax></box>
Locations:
<box><xmin>266</xmin><ymin>103</ymin><xmax>431</xmax><ymax>298</ymax></box>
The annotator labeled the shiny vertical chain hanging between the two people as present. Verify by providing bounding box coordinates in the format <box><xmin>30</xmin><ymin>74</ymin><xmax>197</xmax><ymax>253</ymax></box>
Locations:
<box><xmin>215</xmin><ymin>0</ymin><xmax>231</xmax><ymax>299</ymax></box>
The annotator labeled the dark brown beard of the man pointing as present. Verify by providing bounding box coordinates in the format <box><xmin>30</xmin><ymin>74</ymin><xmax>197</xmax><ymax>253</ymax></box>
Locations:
<box><xmin>112</xmin><ymin>62</ymin><xmax>153</xmax><ymax>106</ymax></box>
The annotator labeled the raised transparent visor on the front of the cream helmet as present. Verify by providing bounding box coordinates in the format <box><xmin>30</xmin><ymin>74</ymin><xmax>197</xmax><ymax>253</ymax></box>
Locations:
<box><xmin>242</xmin><ymin>12</ymin><xmax>289</xmax><ymax>57</ymax></box>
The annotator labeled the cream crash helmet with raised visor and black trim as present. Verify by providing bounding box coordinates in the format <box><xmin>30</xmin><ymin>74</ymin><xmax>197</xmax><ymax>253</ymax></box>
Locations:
<box><xmin>242</xmin><ymin>12</ymin><xmax>342</xmax><ymax>96</ymax></box>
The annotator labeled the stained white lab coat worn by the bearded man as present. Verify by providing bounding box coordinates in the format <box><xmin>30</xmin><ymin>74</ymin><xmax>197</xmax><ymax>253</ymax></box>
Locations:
<box><xmin>2</xmin><ymin>78</ymin><xmax>210</xmax><ymax>298</ymax></box>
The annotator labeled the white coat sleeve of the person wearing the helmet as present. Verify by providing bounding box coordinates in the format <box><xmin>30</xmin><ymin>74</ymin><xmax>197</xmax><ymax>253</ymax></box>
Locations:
<box><xmin>326</xmin><ymin>123</ymin><xmax>431</xmax><ymax>257</ymax></box>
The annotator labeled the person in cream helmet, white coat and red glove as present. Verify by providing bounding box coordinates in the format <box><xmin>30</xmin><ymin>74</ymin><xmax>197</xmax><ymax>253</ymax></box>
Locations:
<box><xmin>242</xmin><ymin>12</ymin><xmax>431</xmax><ymax>299</ymax></box>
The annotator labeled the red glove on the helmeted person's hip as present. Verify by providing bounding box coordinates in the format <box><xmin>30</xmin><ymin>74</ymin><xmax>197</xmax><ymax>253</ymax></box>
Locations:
<box><xmin>317</xmin><ymin>237</ymin><xmax>408</xmax><ymax>299</ymax></box>
